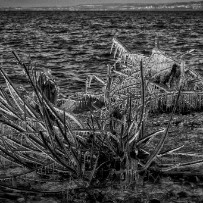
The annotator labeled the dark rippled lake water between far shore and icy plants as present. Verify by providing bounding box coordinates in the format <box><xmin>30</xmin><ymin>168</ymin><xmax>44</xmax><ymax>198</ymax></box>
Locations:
<box><xmin>0</xmin><ymin>11</ymin><xmax>203</xmax><ymax>94</ymax></box>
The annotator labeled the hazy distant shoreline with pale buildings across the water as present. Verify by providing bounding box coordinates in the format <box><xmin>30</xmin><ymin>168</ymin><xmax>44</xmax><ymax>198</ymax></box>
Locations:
<box><xmin>0</xmin><ymin>1</ymin><xmax>203</xmax><ymax>11</ymax></box>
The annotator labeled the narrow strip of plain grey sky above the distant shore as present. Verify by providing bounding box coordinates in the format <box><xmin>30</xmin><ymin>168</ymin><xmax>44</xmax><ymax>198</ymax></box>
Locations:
<box><xmin>0</xmin><ymin>0</ymin><xmax>200</xmax><ymax>7</ymax></box>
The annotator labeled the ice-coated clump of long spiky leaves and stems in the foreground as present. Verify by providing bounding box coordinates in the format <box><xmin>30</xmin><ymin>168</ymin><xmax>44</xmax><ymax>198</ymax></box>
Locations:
<box><xmin>0</xmin><ymin>37</ymin><xmax>200</xmax><ymax>202</ymax></box>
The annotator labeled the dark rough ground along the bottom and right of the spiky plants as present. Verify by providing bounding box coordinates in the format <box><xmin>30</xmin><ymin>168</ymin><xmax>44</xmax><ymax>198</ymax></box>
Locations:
<box><xmin>0</xmin><ymin>113</ymin><xmax>203</xmax><ymax>203</ymax></box>
